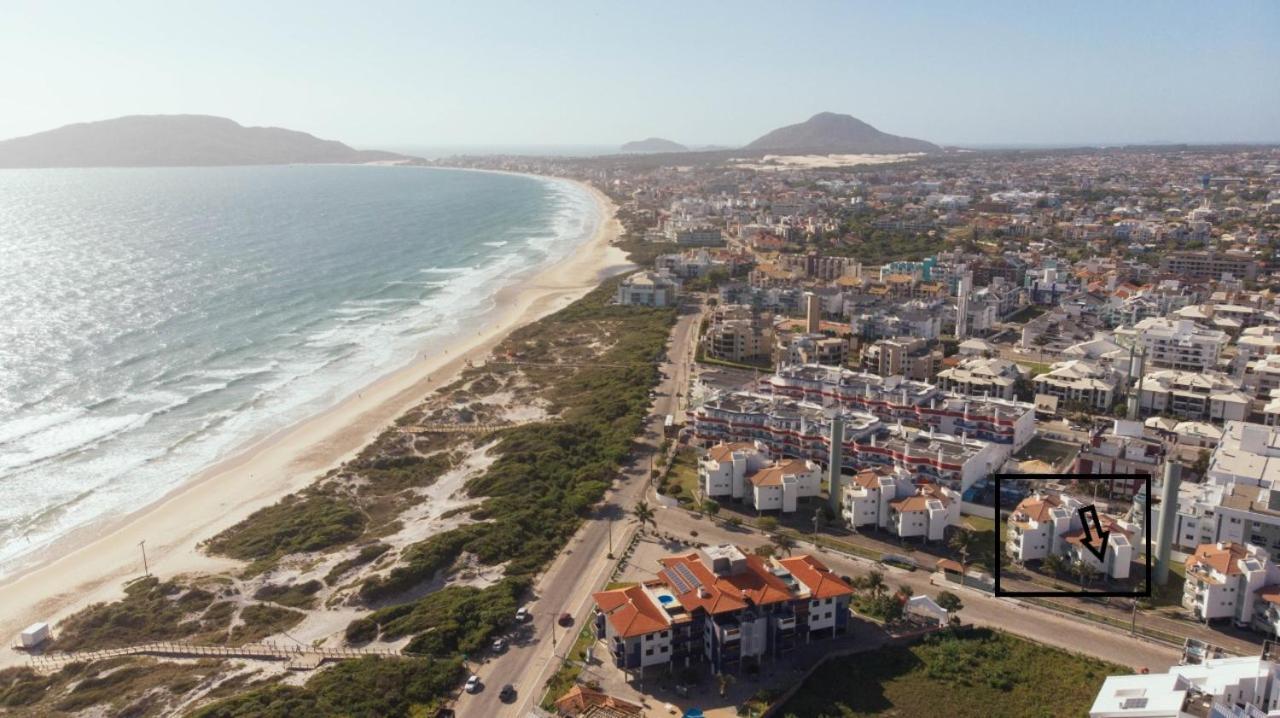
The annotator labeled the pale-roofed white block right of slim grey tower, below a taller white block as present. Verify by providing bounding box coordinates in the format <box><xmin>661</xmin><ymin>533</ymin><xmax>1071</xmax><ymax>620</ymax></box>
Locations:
<box><xmin>1138</xmin><ymin>369</ymin><xmax>1249</xmax><ymax>421</ymax></box>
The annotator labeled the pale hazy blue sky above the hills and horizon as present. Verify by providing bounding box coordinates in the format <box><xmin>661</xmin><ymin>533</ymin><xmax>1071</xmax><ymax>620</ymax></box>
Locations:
<box><xmin>0</xmin><ymin>0</ymin><xmax>1280</xmax><ymax>147</ymax></box>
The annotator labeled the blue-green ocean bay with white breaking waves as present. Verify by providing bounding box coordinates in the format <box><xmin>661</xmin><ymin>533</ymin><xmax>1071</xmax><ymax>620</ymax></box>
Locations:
<box><xmin>0</xmin><ymin>165</ymin><xmax>603</xmax><ymax>576</ymax></box>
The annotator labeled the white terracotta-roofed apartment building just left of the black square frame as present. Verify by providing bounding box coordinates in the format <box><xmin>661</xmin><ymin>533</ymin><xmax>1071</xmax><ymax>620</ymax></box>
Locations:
<box><xmin>842</xmin><ymin>467</ymin><xmax>960</xmax><ymax>541</ymax></box>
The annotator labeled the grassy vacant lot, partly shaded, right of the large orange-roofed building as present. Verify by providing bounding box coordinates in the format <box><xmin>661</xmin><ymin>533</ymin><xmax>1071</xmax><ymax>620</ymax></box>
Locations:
<box><xmin>778</xmin><ymin>628</ymin><xmax>1129</xmax><ymax>718</ymax></box>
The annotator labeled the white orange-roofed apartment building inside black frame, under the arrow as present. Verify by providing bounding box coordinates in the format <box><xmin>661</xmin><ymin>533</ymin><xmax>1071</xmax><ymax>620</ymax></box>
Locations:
<box><xmin>1005</xmin><ymin>493</ymin><xmax>1138</xmax><ymax>580</ymax></box>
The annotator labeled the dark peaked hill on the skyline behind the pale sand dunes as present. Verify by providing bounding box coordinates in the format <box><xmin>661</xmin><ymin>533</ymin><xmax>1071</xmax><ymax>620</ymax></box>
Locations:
<box><xmin>745</xmin><ymin>113</ymin><xmax>941</xmax><ymax>155</ymax></box>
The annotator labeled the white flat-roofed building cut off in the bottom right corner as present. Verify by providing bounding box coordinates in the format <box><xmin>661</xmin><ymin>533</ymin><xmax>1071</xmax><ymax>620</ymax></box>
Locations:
<box><xmin>1089</xmin><ymin>657</ymin><xmax>1280</xmax><ymax>718</ymax></box>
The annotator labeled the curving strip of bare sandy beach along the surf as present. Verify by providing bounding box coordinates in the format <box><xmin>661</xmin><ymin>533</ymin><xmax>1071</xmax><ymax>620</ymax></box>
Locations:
<box><xmin>0</xmin><ymin>177</ymin><xmax>627</xmax><ymax>666</ymax></box>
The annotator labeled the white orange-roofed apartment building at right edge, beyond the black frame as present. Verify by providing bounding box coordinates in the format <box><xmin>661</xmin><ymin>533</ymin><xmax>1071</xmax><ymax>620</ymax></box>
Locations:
<box><xmin>1183</xmin><ymin>543</ymin><xmax>1280</xmax><ymax>626</ymax></box>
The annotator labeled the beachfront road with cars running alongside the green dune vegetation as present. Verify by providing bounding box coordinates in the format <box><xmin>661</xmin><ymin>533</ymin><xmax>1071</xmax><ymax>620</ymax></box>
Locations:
<box><xmin>454</xmin><ymin>296</ymin><xmax>703</xmax><ymax>718</ymax></box>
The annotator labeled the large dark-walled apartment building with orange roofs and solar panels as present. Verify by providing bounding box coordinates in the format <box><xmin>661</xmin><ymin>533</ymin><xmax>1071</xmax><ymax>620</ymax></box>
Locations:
<box><xmin>593</xmin><ymin>545</ymin><xmax>854</xmax><ymax>673</ymax></box>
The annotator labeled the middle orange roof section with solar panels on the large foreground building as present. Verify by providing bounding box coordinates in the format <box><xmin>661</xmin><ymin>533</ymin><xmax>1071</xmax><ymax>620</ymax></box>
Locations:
<box><xmin>658</xmin><ymin>553</ymin><xmax>791</xmax><ymax>613</ymax></box>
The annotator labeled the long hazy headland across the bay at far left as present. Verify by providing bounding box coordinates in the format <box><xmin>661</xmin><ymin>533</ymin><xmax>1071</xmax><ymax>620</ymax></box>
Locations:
<box><xmin>0</xmin><ymin>115</ymin><xmax>415</xmax><ymax>168</ymax></box>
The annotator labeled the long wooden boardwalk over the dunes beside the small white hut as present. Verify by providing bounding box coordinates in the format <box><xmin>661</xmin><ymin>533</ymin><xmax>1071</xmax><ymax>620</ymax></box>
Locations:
<box><xmin>29</xmin><ymin>641</ymin><xmax>406</xmax><ymax>672</ymax></box>
